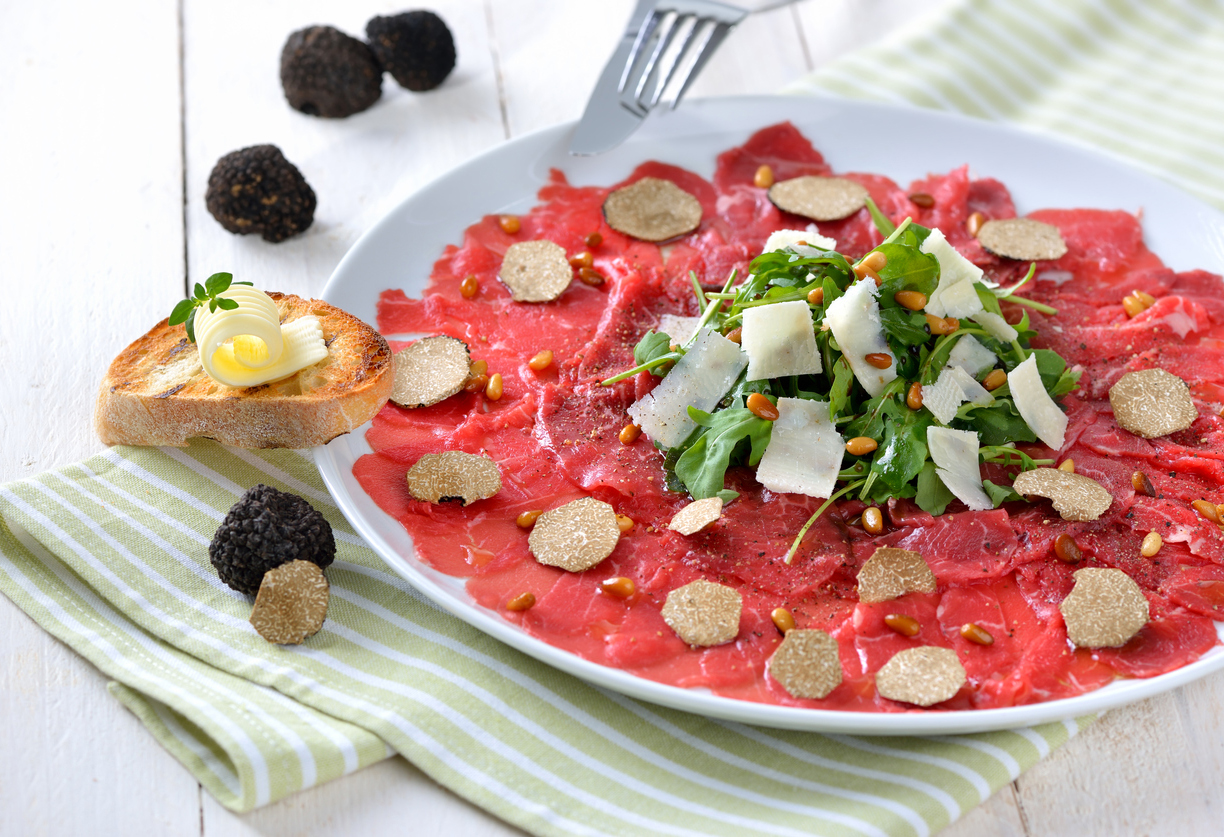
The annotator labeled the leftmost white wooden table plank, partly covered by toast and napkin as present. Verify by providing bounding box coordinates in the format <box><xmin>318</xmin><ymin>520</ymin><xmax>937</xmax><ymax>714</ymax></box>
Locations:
<box><xmin>0</xmin><ymin>0</ymin><xmax>200</xmax><ymax>835</ymax></box>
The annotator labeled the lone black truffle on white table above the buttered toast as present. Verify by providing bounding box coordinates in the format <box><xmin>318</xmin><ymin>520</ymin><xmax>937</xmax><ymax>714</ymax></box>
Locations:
<box><xmin>204</xmin><ymin>146</ymin><xmax>317</xmax><ymax>242</ymax></box>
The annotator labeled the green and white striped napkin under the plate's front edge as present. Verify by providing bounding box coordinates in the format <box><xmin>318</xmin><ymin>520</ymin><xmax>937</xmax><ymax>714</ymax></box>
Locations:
<box><xmin>0</xmin><ymin>442</ymin><xmax>1078</xmax><ymax>837</ymax></box>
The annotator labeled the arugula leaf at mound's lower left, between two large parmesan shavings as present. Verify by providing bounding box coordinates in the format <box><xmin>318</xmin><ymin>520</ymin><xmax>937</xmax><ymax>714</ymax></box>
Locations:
<box><xmin>676</xmin><ymin>406</ymin><xmax>774</xmax><ymax>499</ymax></box>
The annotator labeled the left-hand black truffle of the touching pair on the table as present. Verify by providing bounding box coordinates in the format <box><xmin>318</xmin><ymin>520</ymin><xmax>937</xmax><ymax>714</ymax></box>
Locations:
<box><xmin>280</xmin><ymin>26</ymin><xmax>382</xmax><ymax>119</ymax></box>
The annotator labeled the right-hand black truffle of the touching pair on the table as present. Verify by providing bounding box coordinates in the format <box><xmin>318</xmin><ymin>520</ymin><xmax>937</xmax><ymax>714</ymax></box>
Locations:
<box><xmin>366</xmin><ymin>11</ymin><xmax>455</xmax><ymax>93</ymax></box>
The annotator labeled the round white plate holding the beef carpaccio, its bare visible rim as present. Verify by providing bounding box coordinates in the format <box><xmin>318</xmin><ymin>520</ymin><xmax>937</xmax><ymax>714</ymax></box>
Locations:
<box><xmin>315</xmin><ymin>97</ymin><xmax>1224</xmax><ymax>735</ymax></box>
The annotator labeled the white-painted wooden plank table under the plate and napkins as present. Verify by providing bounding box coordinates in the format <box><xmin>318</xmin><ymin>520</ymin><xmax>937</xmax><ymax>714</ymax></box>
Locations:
<box><xmin>0</xmin><ymin>0</ymin><xmax>1224</xmax><ymax>837</ymax></box>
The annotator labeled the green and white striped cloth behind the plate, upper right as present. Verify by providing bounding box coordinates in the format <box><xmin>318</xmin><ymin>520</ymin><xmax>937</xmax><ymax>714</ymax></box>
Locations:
<box><xmin>786</xmin><ymin>0</ymin><xmax>1224</xmax><ymax>209</ymax></box>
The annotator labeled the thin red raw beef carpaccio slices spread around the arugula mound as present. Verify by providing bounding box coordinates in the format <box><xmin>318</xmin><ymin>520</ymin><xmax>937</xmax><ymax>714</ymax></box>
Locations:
<box><xmin>354</xmin><ymin>124</ymin><xmax>1224</xmax><ymax>712</ymax></box>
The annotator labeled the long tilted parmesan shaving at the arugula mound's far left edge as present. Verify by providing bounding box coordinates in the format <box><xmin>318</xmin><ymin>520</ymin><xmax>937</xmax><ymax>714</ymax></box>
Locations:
<box><xmin>629</xmin><ymin>328</ymin><xmax>748</xmax><ymax>448</ymax></box>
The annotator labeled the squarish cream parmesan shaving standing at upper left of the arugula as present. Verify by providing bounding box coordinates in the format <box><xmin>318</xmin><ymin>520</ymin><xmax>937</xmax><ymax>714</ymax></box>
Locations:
<box><xmin>741</xmin><ymin>300</ymin><xmax>821</xmax><ymax>381</ymax></box>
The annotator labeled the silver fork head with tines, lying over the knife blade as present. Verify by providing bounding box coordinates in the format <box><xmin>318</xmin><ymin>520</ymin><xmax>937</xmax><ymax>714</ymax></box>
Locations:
<box><xmin>617</xmin><ymin>0</ymin><xmax>747</xmax><ymax>116</ymax></box>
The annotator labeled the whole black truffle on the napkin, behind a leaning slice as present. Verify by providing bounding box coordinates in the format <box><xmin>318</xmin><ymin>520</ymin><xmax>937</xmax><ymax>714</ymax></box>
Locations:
<box><xmin>208</xmin><ymin>485</ymin><xmax>335</xmax><ymax>596</ymax></box>
